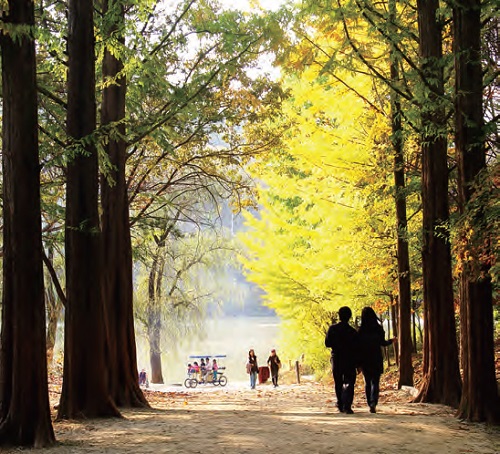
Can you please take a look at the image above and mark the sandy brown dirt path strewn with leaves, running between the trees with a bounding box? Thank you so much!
[6,384,500,454]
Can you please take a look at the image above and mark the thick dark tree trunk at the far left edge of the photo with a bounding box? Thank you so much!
[0,0,55,447]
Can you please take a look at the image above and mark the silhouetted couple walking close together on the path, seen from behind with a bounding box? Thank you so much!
[325,306,395,414]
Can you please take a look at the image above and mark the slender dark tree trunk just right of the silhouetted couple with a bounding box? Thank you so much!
[389,0,413,388]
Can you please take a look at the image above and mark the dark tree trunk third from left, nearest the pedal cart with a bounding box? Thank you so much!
[101,0,148,407]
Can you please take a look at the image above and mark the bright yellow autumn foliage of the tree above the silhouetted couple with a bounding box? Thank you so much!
[241,55,406,370]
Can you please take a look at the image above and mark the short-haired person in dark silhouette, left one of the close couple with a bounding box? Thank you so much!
[325,306,358,414]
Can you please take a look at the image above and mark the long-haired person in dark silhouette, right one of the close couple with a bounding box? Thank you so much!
[358,307,395,413]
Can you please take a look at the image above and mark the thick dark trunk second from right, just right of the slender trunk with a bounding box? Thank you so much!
[416,0,461,407]
